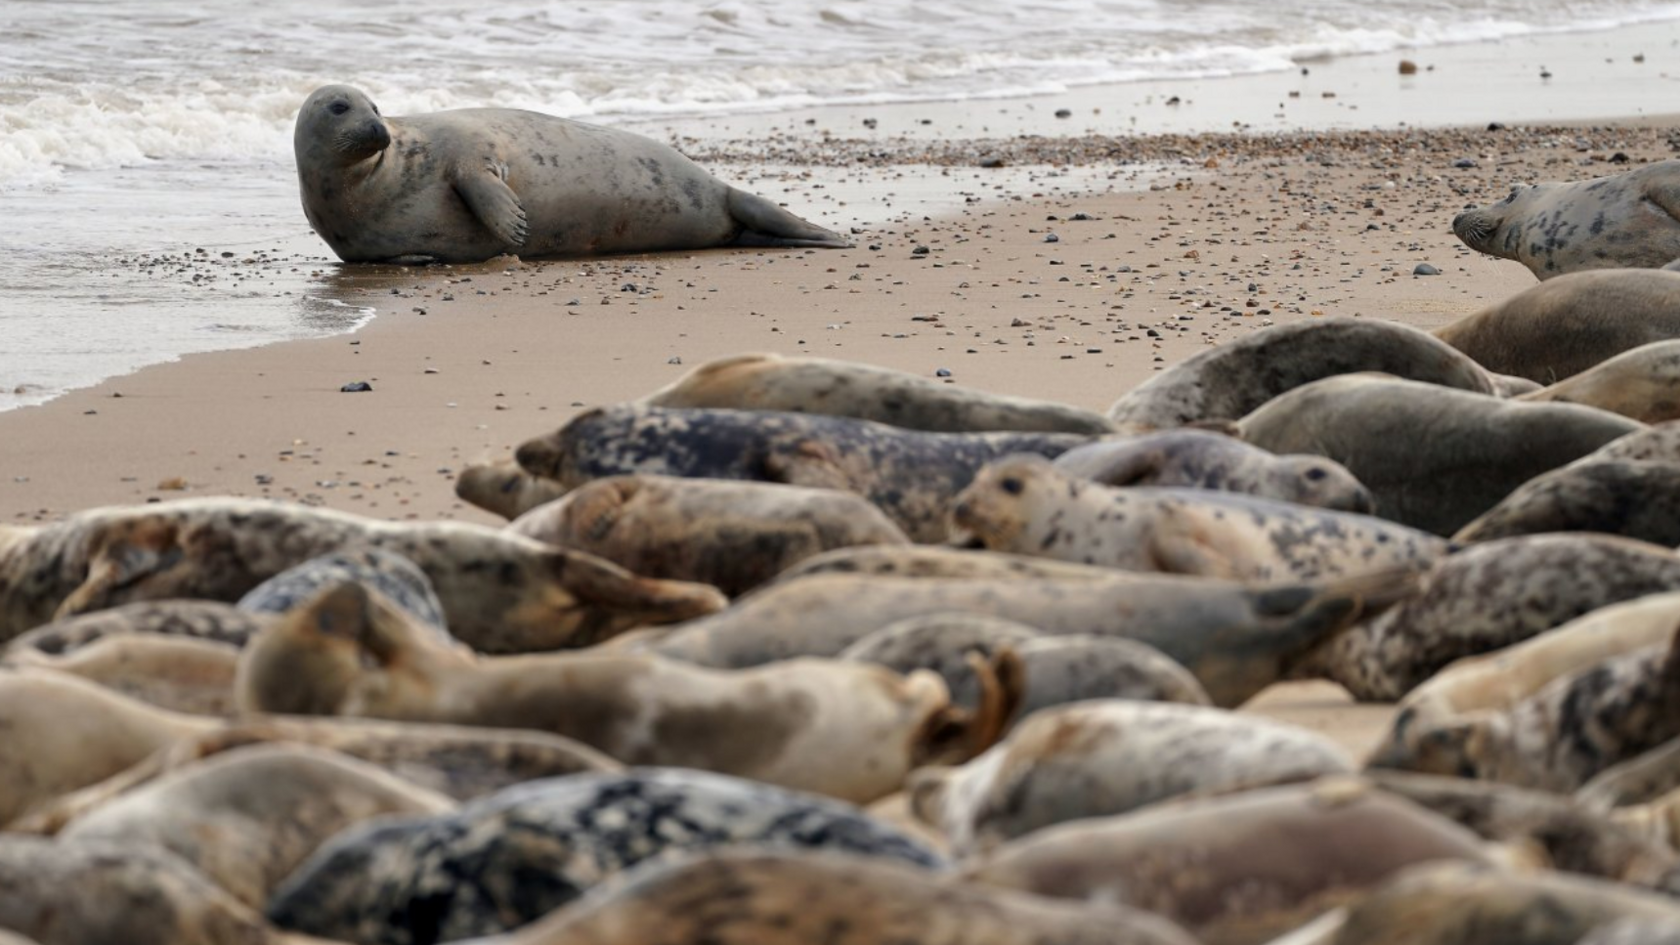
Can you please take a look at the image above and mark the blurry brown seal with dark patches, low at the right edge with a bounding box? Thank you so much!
[1362,768,1680,895]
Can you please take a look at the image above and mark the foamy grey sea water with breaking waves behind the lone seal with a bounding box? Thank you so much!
[0,0,1680,410]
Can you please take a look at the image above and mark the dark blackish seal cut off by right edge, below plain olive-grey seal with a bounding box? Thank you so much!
[1453,461,1680,546]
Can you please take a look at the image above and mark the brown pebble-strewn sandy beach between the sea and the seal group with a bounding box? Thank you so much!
[0,27,1680,747]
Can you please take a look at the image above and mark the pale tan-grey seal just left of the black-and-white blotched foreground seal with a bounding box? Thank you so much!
[59,743,455,910]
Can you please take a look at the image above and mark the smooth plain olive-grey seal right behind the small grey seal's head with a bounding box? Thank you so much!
[1236,375,1643,535]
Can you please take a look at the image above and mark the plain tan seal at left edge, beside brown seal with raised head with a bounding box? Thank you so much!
[0,634,239,716]
